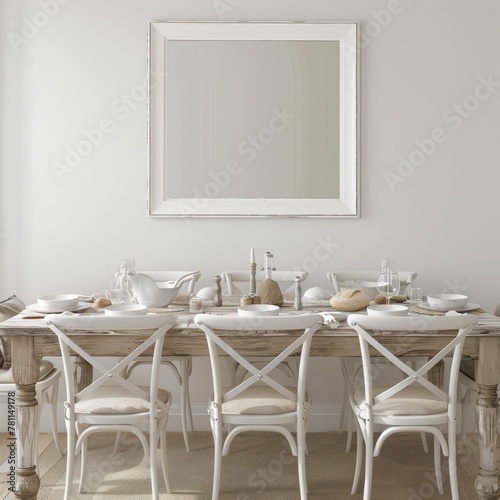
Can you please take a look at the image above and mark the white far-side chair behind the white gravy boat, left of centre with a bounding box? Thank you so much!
[130,271,201,451]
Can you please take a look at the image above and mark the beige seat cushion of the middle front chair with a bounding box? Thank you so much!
[222,386,311,415]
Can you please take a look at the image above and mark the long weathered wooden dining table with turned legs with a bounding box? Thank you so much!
[0,305,500,500]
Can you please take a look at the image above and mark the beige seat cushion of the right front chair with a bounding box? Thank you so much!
[354,385,448,416]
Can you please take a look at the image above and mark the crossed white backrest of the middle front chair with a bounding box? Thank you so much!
[194,314,323,405]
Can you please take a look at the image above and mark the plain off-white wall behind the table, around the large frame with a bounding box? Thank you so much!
[0,0,500,430]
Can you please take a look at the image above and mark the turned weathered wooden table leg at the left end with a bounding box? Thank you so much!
[11,337,40,500]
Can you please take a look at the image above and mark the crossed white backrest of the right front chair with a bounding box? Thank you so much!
[347,314,477,412]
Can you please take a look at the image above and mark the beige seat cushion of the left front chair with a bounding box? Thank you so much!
[75,385,171,415]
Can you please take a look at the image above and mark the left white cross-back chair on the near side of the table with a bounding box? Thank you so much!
[46,314,175,500]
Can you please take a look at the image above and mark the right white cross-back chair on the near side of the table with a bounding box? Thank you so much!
[347,314,477,500]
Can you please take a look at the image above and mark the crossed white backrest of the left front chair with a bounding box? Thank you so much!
[45,314,175,418]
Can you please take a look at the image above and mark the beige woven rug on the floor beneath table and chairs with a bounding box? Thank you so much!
[38,432,477,500]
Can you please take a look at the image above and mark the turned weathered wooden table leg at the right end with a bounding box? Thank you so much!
[474,337,500,500]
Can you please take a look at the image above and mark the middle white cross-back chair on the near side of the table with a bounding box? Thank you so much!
[195,314,323,500]
